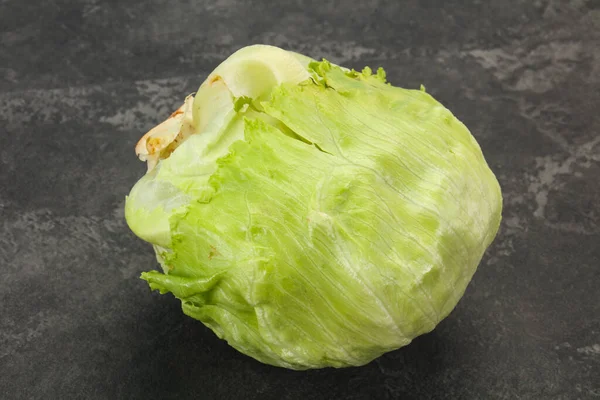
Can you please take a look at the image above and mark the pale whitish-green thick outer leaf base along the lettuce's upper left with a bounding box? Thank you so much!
[125,45,313,248]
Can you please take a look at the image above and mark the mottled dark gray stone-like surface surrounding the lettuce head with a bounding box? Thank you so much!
[0,0,600,400]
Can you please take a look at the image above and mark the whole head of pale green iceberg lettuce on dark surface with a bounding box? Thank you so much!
[125,45,502,369]
